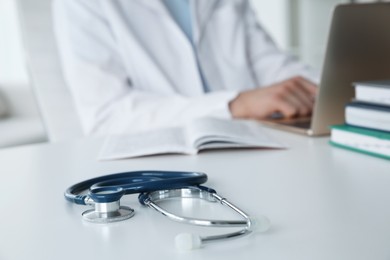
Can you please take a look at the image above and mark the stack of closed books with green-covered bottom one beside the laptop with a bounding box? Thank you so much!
[330,80,390,159]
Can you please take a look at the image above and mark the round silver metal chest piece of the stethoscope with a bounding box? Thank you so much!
[82,201,134,224]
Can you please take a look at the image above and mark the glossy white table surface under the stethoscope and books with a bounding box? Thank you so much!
[0,130,390,260]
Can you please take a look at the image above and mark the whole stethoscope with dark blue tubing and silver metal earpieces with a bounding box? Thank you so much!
[64,171,270,250]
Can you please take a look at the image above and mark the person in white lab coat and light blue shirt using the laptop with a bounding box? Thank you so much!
[54,0,316,135]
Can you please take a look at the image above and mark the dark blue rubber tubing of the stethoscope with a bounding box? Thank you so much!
[64,171,207,205]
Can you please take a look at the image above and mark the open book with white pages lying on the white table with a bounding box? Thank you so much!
[99,118,285,160]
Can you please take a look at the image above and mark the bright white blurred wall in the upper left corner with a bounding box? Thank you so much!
[0,0,29,86]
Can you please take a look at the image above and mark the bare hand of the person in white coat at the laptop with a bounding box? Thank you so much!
[229,77,317,119]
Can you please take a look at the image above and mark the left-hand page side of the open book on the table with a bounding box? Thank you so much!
[99,128,197,160]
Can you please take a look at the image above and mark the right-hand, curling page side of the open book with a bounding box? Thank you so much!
[186,118,285,150]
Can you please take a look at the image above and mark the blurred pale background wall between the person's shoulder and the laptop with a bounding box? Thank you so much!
[252,0,349,70]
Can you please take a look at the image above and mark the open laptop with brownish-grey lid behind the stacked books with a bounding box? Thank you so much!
[264,3,390,136]
